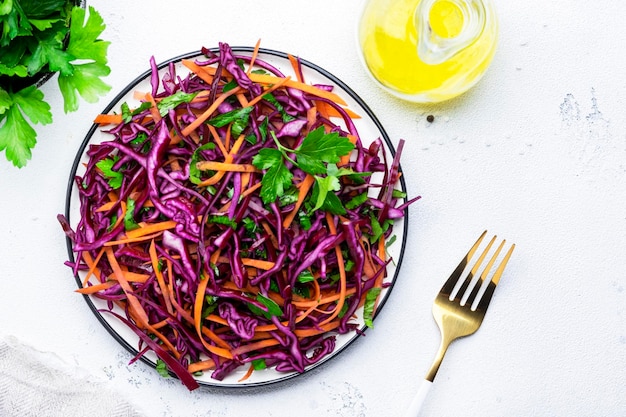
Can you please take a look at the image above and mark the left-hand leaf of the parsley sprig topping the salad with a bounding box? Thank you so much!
[252,148,293,204]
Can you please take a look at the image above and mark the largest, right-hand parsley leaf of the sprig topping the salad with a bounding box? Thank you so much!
[295,126,354,174]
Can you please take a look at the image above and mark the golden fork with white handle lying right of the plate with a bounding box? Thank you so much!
[405,230,515,417]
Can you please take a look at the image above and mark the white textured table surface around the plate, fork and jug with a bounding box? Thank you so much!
[0,0,626,417]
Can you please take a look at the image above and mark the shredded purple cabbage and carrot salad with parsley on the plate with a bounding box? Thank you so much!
[59,43,417,390]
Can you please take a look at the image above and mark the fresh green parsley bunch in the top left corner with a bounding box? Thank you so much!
[0,0,111,168]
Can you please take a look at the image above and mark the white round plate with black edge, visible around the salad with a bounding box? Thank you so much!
[65,47,408,387]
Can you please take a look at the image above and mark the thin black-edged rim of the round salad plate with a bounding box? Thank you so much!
[64,46,409,390]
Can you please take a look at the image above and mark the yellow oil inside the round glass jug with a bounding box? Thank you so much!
[358,0,497,102]
